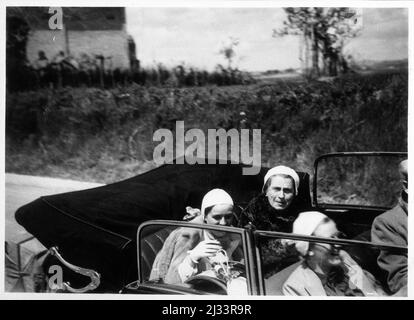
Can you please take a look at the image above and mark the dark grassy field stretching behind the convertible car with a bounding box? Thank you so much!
[6,71,408,183]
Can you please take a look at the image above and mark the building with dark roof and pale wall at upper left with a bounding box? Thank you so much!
[7,7,137,69]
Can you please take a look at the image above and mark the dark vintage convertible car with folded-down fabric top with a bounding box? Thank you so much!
[15,152,407,295]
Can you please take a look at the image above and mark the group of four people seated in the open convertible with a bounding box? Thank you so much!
[150,160,408,296]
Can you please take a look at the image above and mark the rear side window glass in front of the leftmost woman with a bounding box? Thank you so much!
[138,224,248,295]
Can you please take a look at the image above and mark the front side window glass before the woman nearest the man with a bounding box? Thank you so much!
[256,232,407,297]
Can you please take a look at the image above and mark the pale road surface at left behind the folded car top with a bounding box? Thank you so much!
[5,173,102,251]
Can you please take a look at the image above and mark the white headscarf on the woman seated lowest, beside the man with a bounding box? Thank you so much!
[293,211,328,256]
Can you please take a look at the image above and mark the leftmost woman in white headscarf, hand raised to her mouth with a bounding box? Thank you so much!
[150,189,241,284]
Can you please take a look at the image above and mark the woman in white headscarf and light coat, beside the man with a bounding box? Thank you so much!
[283,211,385,296]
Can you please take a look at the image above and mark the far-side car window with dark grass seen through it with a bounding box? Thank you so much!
[316,155,406,208]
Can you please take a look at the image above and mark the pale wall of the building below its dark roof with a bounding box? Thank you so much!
[26,26,130,69]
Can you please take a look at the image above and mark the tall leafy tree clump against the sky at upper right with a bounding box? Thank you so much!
[273,7,360,77]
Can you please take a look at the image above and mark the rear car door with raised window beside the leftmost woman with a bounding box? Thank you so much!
[123,220,258,295]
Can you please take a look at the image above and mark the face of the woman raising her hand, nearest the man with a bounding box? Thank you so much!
[308,220,342,270]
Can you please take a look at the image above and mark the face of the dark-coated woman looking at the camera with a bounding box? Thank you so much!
[266,175,295,210]
